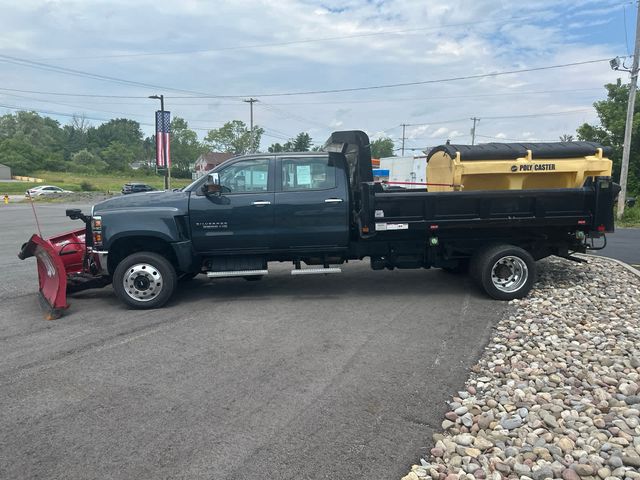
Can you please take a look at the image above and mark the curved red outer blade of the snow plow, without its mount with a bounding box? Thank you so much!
[18,234,68,320]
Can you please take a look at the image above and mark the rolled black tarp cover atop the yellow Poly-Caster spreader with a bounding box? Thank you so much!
[427,142,611,161]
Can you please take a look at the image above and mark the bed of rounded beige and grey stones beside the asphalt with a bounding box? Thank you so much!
[403,258,640,480]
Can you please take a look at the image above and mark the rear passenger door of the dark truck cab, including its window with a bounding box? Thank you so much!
[273,153,349,251]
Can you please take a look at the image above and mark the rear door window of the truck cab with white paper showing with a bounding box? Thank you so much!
[282,157,336,192]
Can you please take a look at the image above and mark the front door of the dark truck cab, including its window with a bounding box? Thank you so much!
[189,157,274,253]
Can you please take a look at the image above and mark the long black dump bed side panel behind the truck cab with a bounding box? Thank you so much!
[361,178,617,235]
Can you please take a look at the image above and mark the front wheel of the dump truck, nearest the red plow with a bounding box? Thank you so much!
[113,252,177,310]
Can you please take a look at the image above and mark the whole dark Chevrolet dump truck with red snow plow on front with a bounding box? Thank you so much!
[20,131,619,316]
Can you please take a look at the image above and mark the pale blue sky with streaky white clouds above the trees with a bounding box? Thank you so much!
[0,0,637,154]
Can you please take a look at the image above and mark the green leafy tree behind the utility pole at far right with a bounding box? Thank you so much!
[577,79,640,194]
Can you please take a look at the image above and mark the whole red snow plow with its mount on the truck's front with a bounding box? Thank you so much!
[18,211,109,320]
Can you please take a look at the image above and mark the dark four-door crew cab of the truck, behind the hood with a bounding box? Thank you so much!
[186,152,349,255]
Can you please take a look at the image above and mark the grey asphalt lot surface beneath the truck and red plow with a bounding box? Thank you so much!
[0,204,506,479]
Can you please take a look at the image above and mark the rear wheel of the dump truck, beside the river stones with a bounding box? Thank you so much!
[470,245,536,300]
